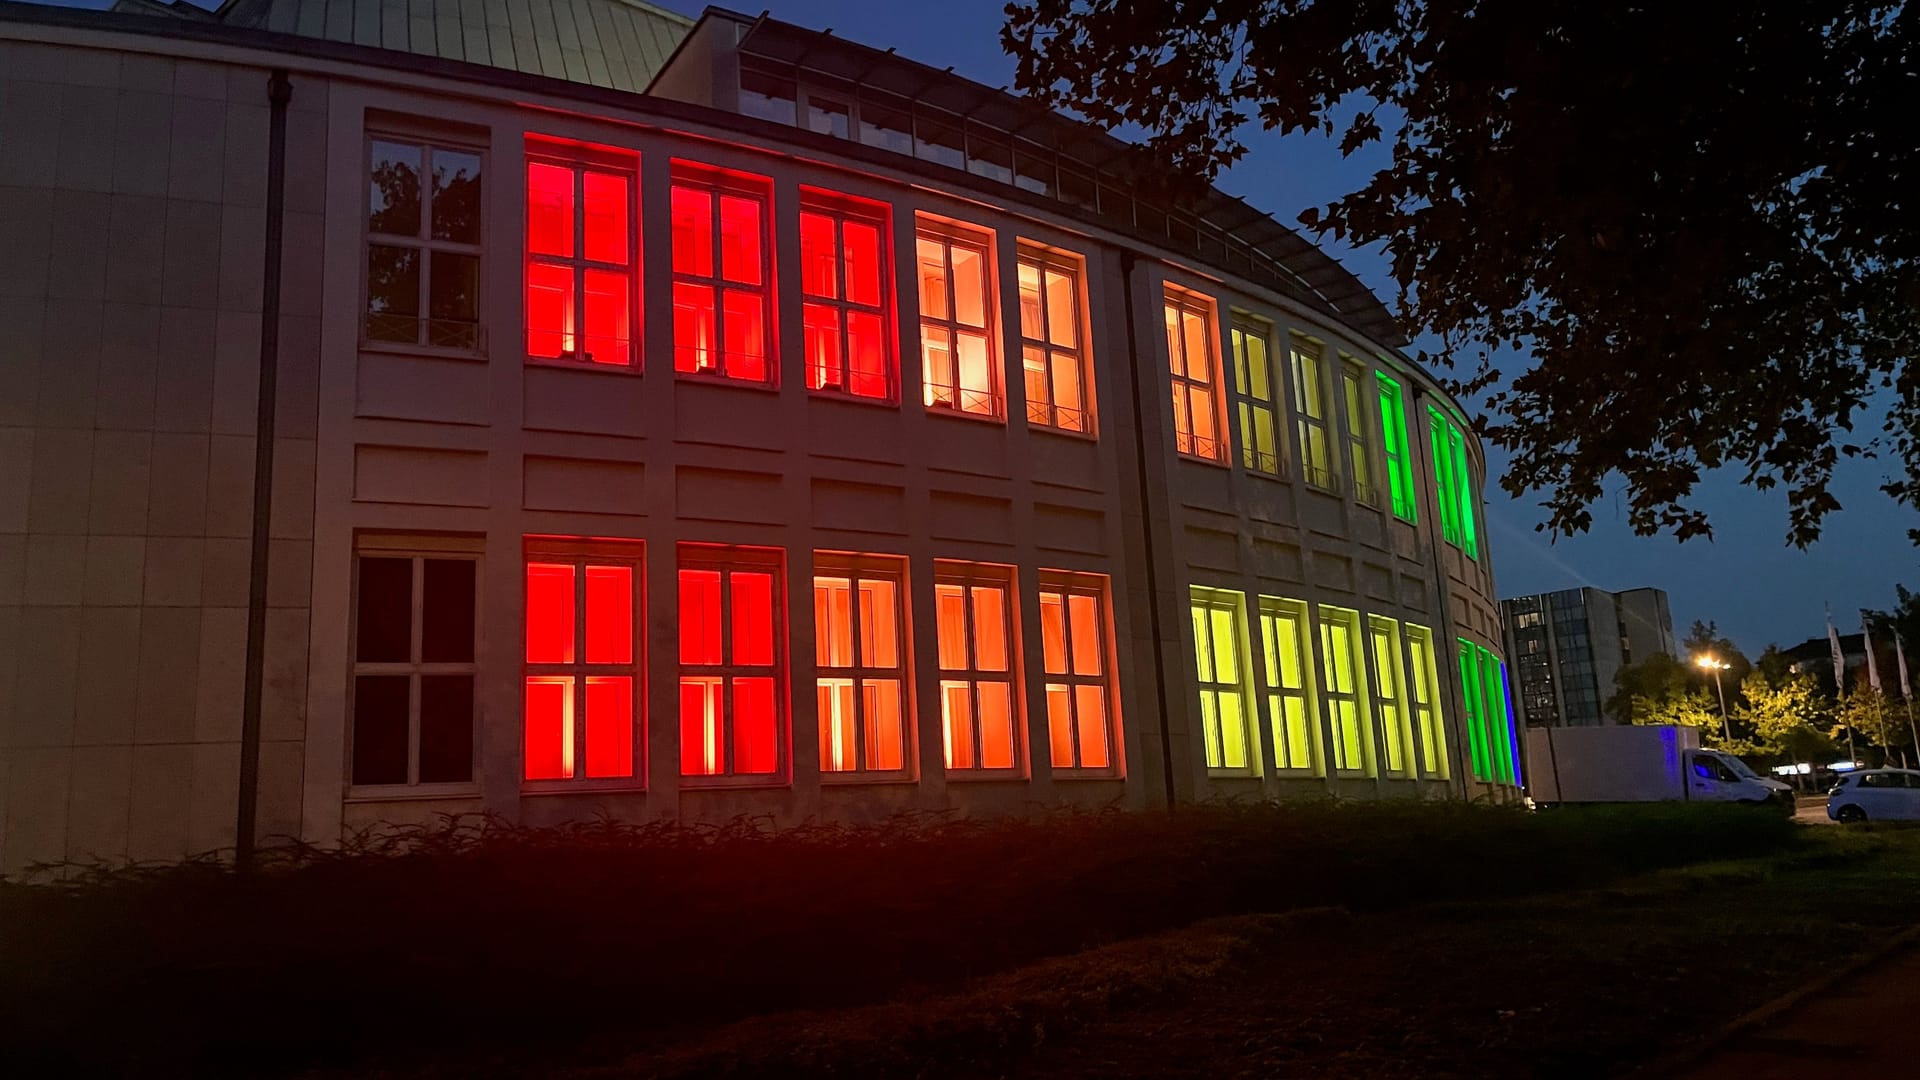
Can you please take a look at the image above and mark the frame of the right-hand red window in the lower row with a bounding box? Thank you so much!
[674,540,793,788]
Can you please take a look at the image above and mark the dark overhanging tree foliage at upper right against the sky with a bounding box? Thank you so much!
[1002,0,1920,544]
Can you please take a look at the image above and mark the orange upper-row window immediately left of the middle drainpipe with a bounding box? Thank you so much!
[1020,244,1092,432]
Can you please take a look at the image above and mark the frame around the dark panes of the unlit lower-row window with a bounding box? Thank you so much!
[342,536,486,801]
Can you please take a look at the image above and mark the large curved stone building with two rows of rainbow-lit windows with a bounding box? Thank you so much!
[0,0,1517,869]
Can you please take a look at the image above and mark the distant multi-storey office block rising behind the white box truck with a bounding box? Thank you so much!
[1500,588,1676,726]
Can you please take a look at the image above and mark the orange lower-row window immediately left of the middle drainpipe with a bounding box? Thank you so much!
[1041,571,1114,771]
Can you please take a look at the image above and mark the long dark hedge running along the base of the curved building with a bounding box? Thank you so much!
[0,801,1791,1074]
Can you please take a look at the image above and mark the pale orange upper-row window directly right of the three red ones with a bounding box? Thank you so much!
[914,219,1000,417]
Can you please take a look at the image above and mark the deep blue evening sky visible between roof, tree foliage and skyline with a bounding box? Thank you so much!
[48,0,1920,653]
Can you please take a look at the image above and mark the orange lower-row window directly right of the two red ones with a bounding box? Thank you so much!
[814,552,908,776]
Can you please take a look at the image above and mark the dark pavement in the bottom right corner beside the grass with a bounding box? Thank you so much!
[1663,942,1920,1080]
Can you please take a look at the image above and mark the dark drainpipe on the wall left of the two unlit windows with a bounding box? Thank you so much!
[234,69,294,871]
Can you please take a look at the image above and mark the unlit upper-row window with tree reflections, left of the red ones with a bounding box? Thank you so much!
[365,136,484,350]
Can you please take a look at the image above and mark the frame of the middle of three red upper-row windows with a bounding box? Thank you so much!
[666,158,780,390]
